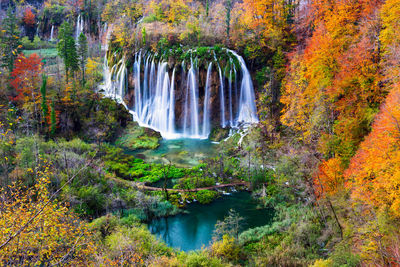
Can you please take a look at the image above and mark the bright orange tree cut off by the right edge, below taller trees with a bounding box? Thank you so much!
[345,84,400,218]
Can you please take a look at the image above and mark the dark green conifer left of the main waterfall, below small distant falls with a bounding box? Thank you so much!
[57,21,79,83]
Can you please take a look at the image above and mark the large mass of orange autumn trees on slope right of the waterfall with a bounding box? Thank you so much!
[281,0,385,201]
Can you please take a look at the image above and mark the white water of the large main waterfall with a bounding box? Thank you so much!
[100,50,258,139]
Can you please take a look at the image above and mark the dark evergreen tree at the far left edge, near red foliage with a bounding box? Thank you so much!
[0,7,21,73]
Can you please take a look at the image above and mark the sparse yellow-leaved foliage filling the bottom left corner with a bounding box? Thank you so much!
[0,166,95,266]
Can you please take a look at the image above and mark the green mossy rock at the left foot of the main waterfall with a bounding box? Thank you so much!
[115,122,161,150]
